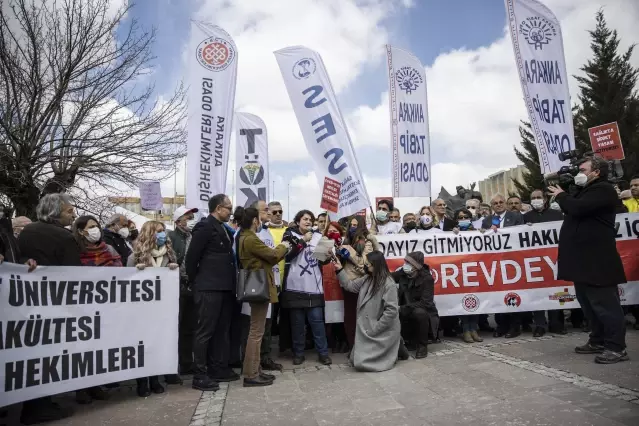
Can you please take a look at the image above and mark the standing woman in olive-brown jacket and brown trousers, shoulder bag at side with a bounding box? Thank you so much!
[233,207,290,387]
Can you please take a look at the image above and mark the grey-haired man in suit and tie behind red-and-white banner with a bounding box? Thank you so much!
[481,194,524,339]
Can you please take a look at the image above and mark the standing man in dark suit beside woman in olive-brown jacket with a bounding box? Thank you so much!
[185,194,240,391]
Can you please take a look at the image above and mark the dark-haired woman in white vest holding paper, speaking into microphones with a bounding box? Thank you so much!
[280,210,332,365]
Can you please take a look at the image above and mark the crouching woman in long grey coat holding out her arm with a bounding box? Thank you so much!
[334,251,401,371]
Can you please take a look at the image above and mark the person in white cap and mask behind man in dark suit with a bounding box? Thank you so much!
[166,206,198,376]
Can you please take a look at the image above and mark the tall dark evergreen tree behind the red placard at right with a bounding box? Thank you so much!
[574,11,639,180]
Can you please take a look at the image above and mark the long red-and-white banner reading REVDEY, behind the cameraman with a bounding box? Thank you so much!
[324,213,639,316]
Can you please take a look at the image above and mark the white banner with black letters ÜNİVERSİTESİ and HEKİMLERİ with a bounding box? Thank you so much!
[0,262,180,407]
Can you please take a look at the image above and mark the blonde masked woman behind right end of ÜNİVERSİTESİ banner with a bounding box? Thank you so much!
[126,220,178,398]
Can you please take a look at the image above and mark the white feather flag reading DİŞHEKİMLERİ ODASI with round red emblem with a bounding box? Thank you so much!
[186,21,237,214]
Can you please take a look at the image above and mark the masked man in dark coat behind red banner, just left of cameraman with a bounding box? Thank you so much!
[524,189,567,337]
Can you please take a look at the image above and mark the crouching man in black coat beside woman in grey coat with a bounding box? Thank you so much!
[392,251,439,359]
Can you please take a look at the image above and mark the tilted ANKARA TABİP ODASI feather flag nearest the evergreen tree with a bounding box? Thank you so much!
[505,0,575,174]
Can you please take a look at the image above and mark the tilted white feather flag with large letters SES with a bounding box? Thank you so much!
[275,46,370,217]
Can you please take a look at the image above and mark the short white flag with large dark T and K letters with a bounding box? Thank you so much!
[235,112,270,207]
